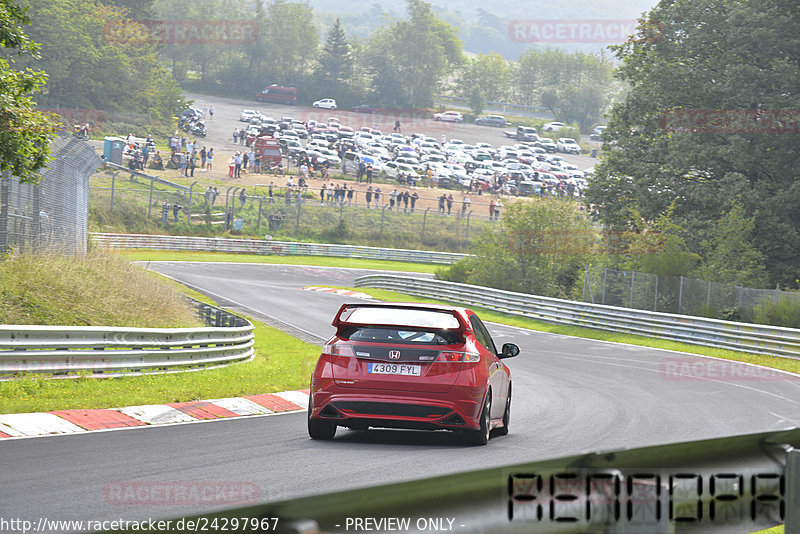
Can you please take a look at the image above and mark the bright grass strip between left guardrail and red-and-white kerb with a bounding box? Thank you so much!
[0,321,320,413]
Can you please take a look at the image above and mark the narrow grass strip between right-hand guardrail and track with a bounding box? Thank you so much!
[345,287,800,373]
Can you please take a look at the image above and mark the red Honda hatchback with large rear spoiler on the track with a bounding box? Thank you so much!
[308,303,519,445]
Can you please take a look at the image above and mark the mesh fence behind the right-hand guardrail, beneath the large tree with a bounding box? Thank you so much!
[582,267,800,320]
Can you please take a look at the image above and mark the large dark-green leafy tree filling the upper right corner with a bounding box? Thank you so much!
[587,0,800,285]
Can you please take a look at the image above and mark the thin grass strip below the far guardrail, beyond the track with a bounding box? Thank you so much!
[116,249,441,274]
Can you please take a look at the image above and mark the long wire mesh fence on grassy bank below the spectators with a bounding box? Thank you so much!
[91,182,499,251]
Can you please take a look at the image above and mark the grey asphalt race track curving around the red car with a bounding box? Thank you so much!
[0,263,800,520]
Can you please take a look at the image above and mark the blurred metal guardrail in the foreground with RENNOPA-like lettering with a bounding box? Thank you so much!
[139,428,800,534]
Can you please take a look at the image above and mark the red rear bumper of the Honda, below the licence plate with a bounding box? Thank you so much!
[310,381,485,430]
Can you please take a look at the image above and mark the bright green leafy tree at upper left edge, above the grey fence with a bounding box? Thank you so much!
[0,0,56,183]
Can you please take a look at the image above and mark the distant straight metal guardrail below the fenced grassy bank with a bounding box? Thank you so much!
[89,233,468,265]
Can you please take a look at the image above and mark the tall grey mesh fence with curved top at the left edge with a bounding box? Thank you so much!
[0,136,101,254]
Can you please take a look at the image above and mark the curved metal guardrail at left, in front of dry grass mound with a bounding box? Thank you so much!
[0,302,255,378]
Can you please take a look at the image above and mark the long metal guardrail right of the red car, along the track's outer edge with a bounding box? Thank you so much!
[355,275,800,358]
